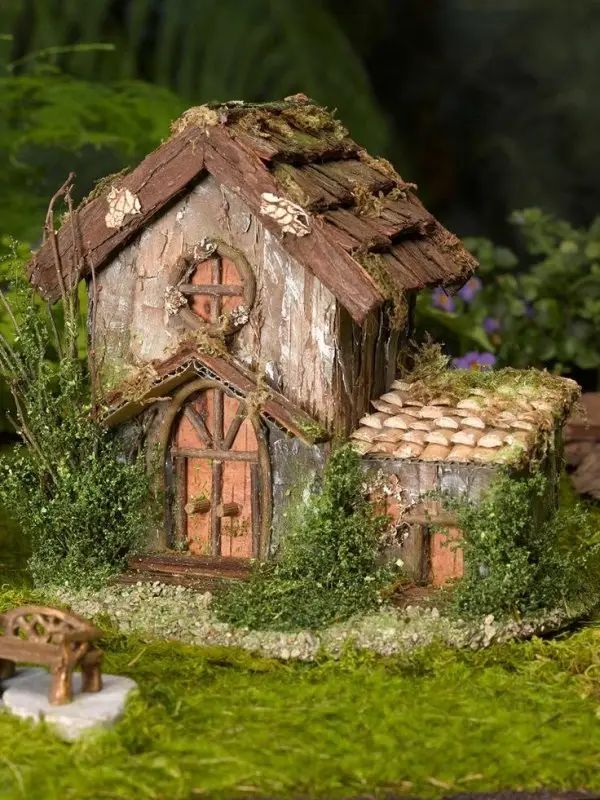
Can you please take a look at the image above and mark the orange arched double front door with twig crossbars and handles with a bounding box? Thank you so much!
[167,380,271,558]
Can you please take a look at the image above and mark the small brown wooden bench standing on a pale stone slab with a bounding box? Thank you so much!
[0,606,102,705]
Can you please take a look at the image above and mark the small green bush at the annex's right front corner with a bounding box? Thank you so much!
[448,474,600,616]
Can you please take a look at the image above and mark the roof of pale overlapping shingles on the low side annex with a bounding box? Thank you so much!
[351,378,577,464]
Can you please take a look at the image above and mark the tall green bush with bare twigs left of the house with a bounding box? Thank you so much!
[0,236,150,586]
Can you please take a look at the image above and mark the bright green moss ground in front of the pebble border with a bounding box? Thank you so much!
[0,590,600,800]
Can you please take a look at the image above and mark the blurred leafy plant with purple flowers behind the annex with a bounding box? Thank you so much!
[418,208,600,382]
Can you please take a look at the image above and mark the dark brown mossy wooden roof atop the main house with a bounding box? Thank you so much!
[28,95,476,324]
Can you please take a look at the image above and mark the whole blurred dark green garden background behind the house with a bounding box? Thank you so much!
[0,0,600,404]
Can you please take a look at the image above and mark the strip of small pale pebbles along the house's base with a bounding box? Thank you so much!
[53,582,590,662]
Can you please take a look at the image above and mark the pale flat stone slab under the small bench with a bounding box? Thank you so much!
[0,668,137,741]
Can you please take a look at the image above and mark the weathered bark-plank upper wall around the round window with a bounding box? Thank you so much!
[96,176,394,435]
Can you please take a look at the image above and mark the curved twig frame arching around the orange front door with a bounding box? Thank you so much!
[158,378,273,560]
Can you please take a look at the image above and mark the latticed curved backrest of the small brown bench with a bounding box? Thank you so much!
[0,606,101,645]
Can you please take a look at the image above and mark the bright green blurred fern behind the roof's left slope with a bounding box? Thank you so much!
[0,71,184,243]
